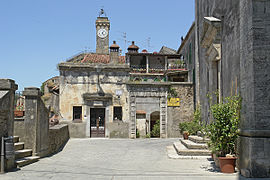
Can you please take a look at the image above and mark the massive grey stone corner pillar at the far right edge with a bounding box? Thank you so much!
[239,0,270,178]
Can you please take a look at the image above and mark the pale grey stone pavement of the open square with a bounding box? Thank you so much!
[0,139,266,180]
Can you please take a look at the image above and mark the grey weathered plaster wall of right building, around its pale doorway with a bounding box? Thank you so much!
[195,0,240,121]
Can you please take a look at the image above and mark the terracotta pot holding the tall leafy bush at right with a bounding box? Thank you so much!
[218,157,237,173]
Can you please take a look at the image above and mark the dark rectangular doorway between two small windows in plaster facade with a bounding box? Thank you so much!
[90,108,105,137]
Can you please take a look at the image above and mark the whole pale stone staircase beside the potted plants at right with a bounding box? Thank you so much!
[167,136,211,159]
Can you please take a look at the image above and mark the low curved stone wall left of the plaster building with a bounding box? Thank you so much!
[48,124,69,154]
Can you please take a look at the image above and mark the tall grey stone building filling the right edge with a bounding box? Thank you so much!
[194,0,270,177]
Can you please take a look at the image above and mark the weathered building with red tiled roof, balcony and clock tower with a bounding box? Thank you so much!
[58,11,194,138]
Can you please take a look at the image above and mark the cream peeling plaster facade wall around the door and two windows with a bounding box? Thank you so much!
[59,65,129,137]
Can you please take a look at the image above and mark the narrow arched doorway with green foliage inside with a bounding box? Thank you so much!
[150,111,160,137]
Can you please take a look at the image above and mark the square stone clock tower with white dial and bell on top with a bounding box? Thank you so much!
[96,9,110,54]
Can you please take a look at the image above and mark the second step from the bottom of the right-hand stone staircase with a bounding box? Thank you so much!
[173,142,211,156]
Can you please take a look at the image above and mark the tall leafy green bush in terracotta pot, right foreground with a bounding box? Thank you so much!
[208,96,241,173]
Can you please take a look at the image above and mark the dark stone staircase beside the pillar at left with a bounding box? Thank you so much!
[13,136,39,167]
